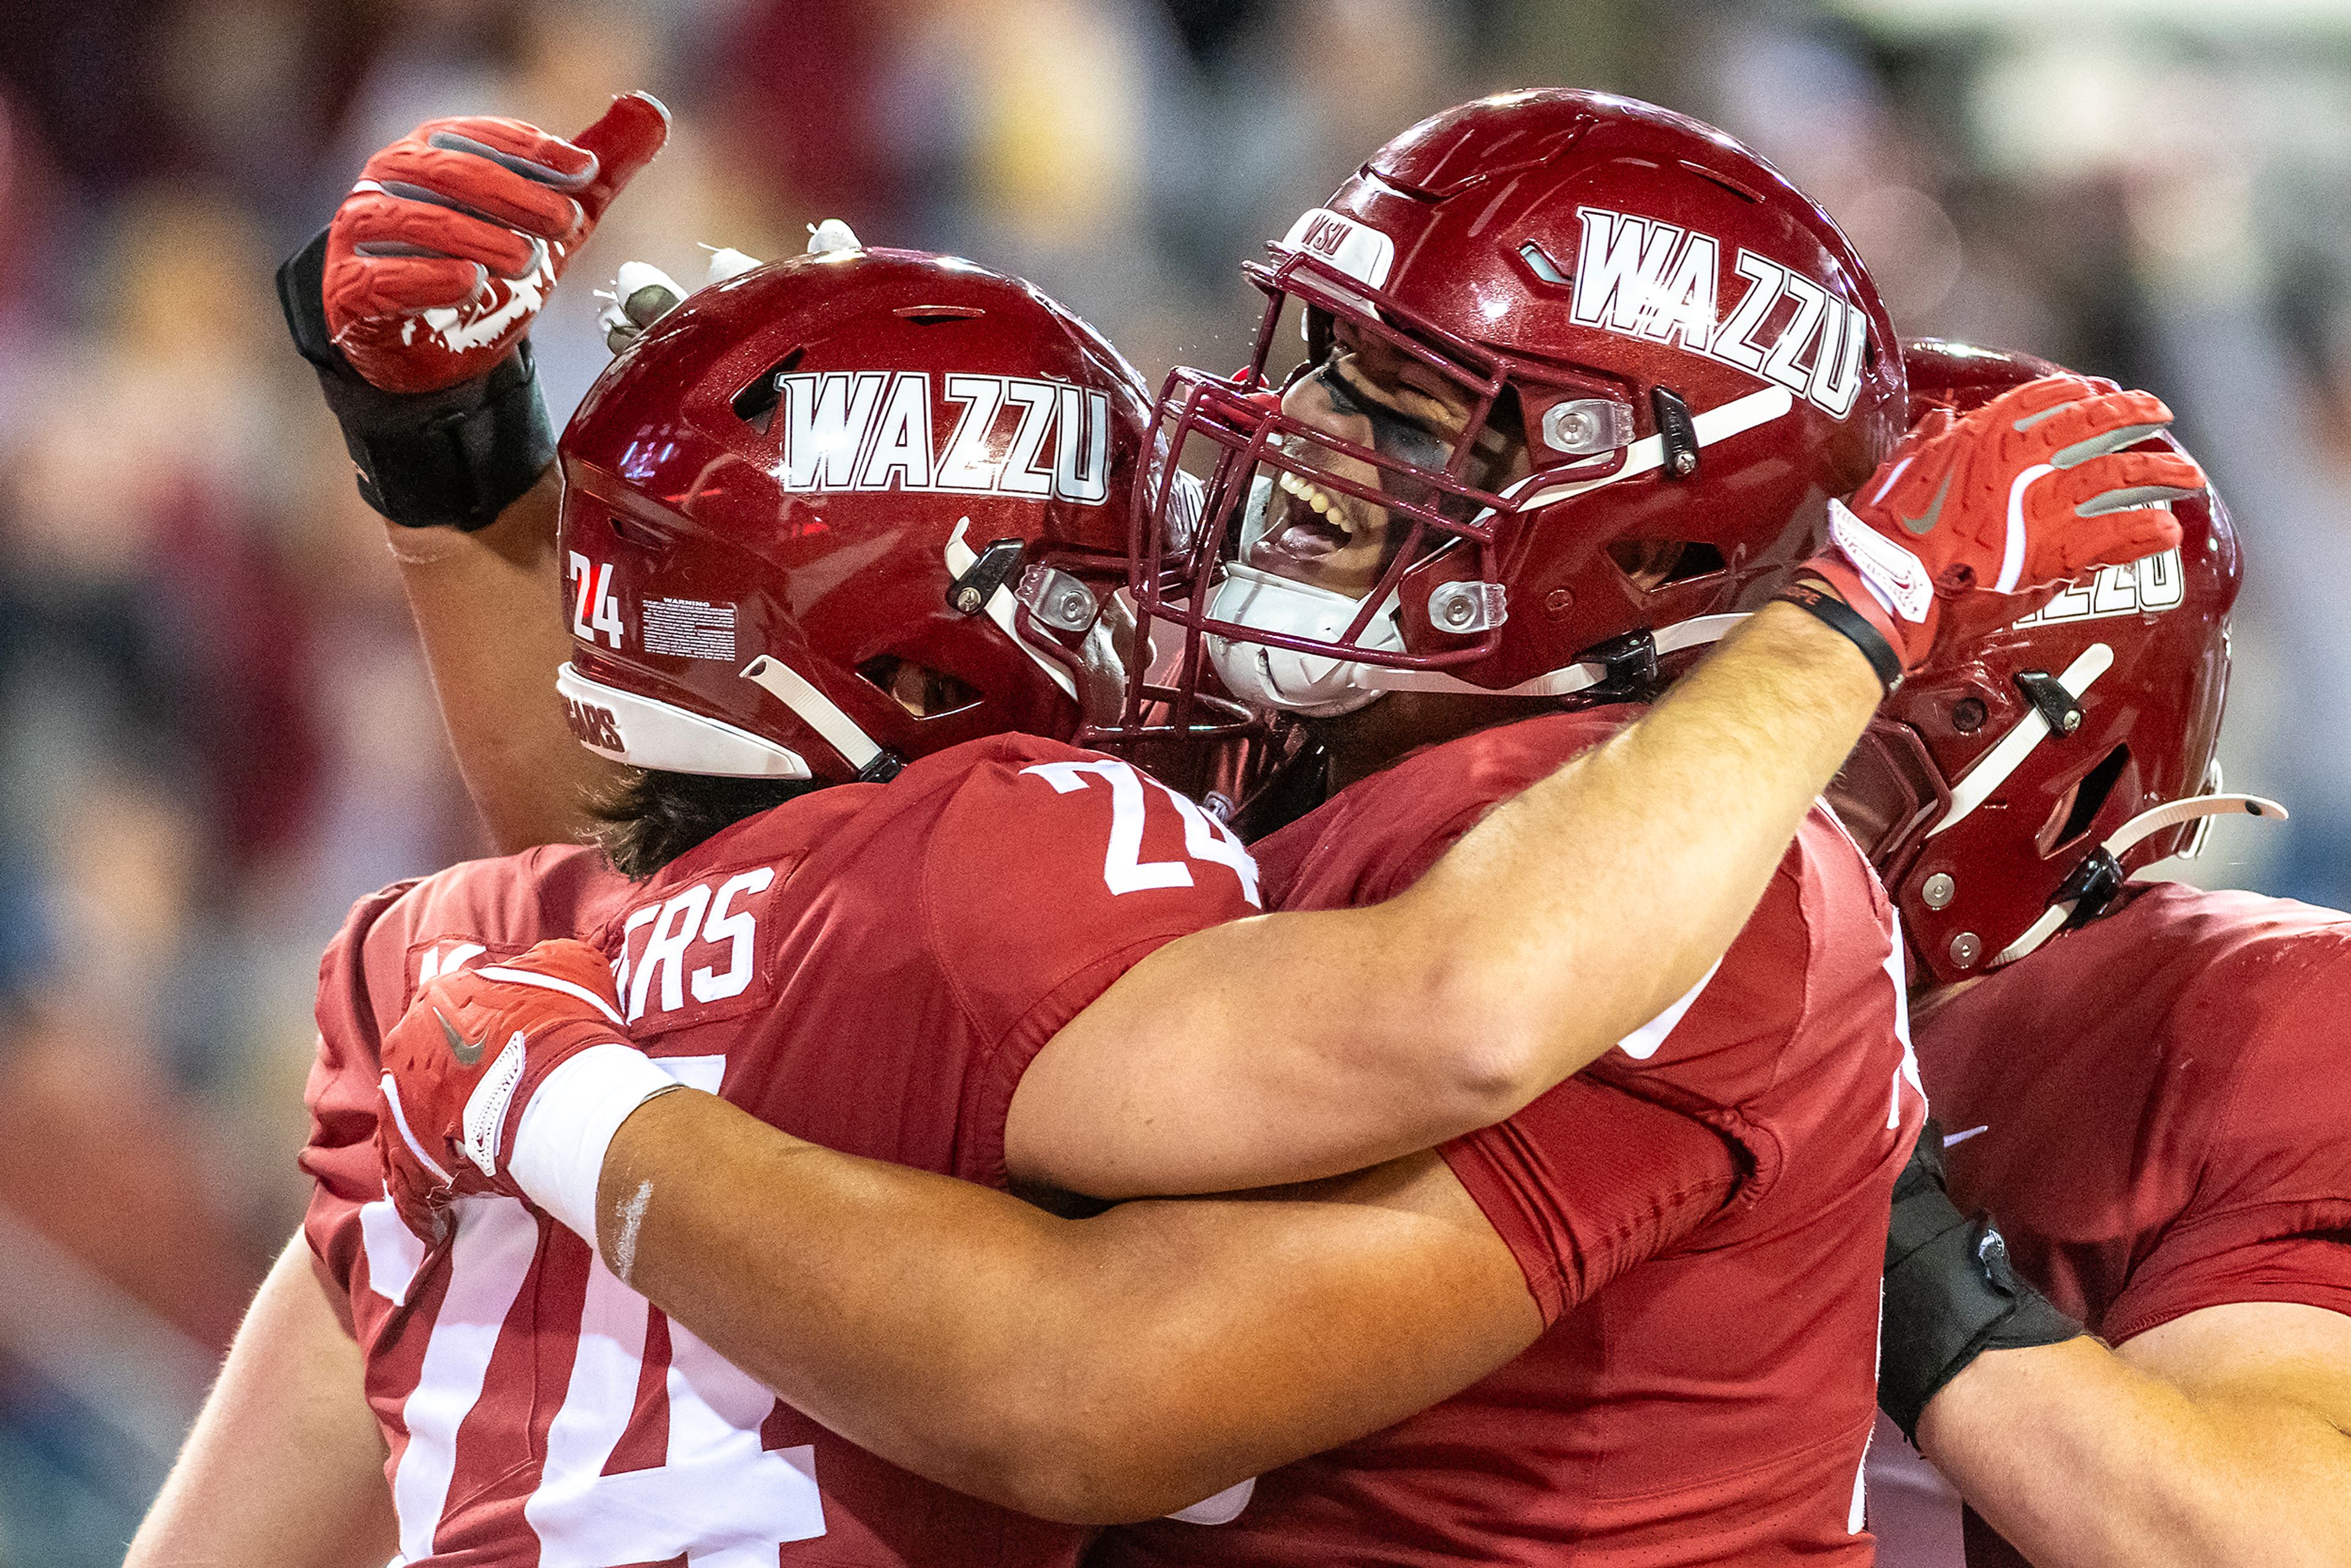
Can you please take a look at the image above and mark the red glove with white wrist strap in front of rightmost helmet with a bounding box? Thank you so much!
[1803,376,2205,670]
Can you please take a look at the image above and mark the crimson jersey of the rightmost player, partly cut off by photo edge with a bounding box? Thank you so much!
[1872,882,2351,1568]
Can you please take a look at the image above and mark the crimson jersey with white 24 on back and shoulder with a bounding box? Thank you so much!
[303,736,1258,1568]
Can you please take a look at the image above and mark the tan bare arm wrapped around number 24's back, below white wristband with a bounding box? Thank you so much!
[597,1093,1540,1523]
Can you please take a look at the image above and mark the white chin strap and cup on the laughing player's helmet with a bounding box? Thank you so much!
[1209,564,1747,719]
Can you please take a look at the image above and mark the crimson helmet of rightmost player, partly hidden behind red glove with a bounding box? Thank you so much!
[1829,341,2285,983]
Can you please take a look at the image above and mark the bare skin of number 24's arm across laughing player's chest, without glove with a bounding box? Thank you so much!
[1007,604,1883,1196]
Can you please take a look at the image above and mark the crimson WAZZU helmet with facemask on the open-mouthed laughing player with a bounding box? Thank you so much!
[1133,92,1904,715]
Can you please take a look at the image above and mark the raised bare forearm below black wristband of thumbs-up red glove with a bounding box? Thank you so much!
[386,468,611,853]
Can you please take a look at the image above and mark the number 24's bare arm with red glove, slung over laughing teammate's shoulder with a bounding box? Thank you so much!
[1007,376,2203,1196]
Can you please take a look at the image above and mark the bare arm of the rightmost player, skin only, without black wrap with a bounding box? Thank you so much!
[1918,1302,2351,1568]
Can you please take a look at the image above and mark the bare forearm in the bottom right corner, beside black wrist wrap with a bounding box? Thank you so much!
[1918,1338,2351,1568]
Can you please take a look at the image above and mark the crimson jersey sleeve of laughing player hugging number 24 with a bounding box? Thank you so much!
[1439,1077,1744,1326]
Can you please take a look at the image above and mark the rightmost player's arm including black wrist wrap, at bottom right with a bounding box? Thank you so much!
[1878,1105,2351,1568]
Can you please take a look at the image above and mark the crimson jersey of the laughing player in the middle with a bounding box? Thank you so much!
[1093,708,1923,1568]
